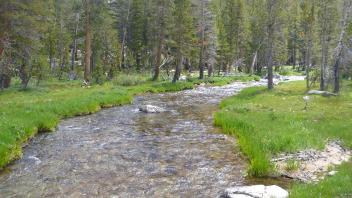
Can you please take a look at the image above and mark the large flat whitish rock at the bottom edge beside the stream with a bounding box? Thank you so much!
[219,185,288,198]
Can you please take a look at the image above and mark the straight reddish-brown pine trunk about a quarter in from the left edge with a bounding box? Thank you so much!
[84,0,92,83]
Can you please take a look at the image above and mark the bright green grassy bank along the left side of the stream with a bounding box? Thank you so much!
[0,75,259,169]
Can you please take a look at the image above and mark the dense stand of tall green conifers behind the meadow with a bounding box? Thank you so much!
[0,0,352,92]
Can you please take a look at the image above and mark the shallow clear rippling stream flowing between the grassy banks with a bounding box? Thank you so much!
[0,81,302,197]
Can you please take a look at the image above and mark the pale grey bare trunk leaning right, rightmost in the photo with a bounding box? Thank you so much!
[333,0,352,93]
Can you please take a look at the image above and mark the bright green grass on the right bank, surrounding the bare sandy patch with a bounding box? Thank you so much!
[215,81,352,197]
